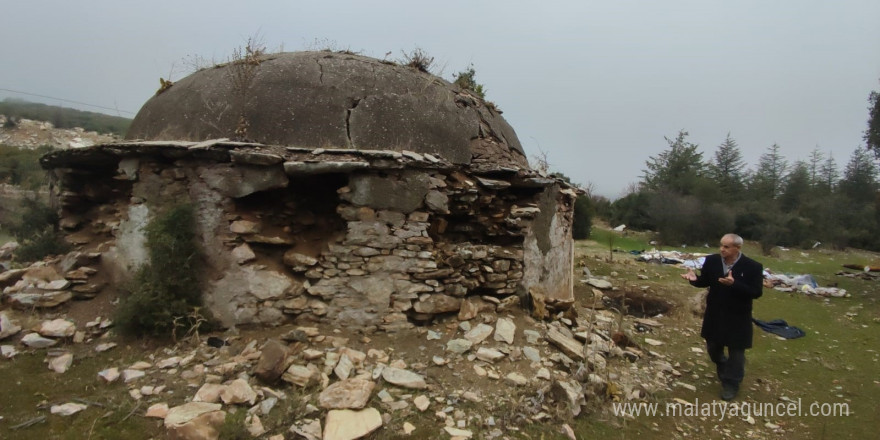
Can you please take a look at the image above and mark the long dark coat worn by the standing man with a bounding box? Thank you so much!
[691,254,764,348]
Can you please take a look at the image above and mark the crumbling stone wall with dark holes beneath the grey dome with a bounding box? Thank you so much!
[44,143,576,331]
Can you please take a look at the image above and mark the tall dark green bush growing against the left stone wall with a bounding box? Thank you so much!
[116,205,204,336]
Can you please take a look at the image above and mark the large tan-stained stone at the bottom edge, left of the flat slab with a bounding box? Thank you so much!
[165,402,226,440]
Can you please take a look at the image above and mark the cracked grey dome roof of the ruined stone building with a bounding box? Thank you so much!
[126,52,528,168]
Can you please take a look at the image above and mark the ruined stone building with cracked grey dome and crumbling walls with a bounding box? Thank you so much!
[42,52,577,330]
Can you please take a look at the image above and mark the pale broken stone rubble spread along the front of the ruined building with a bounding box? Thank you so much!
[0,300,681,439]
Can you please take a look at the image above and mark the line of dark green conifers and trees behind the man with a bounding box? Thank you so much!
[574,83,880,252]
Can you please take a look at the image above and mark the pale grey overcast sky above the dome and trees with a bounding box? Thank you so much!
[0,0,880,198]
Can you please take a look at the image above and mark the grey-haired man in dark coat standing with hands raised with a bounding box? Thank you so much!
[681,234,764,400]
